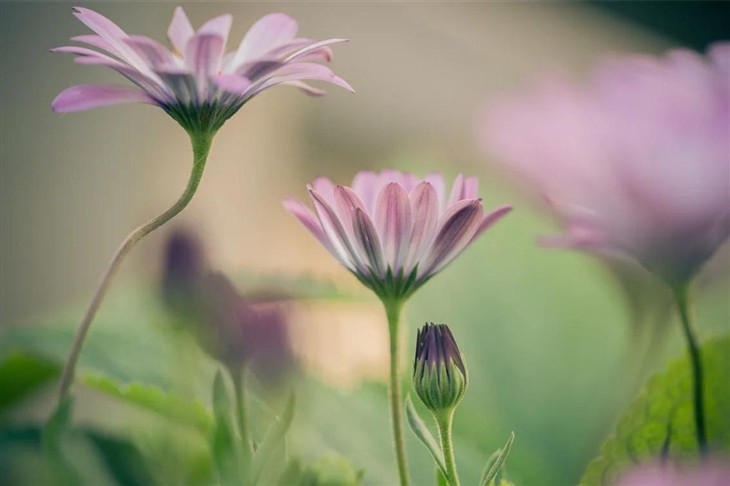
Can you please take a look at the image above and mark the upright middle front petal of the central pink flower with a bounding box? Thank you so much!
[374,182,413,274]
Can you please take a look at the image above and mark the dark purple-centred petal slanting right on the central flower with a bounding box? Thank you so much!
[418,199,484,278]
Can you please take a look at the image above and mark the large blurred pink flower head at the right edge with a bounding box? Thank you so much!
[479,43,730,285]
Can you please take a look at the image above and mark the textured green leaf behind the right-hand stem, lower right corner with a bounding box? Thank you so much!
[581,336,730,486]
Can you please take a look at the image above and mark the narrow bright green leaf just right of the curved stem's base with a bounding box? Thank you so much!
[81,373,213,434]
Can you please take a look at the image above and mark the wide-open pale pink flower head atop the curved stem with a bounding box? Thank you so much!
[52,7,352,129]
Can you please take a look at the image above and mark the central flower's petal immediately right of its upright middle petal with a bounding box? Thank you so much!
[406,181,439,269]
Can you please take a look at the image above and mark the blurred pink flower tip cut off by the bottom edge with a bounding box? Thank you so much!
[616,461,730,486]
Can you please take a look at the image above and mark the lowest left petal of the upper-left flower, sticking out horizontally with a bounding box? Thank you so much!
[51,84,156,113]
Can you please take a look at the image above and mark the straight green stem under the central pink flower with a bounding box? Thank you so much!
[383,298,410,486]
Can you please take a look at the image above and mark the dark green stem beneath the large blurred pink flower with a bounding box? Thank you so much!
[674,284,707,455]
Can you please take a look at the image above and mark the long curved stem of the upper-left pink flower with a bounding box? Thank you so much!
[58,132,215,403]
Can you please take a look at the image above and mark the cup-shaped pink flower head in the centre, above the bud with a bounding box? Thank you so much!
[284,170,511,297]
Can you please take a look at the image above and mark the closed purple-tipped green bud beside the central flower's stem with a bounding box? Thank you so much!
[413,323,467,414]
